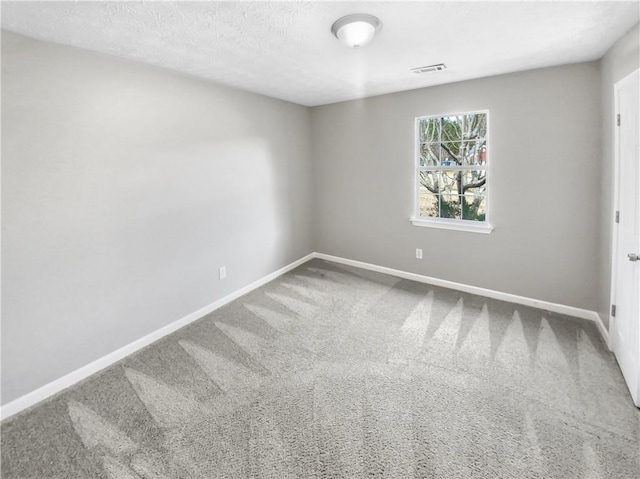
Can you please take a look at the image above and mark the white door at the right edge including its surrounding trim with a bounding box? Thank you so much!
[610,70,640,407]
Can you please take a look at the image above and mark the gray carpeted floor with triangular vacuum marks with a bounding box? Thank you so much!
[2,259,640,479]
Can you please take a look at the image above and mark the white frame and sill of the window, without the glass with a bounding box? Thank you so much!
[411,110,493,234]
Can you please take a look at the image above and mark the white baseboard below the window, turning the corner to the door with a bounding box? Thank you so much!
[313,253,610,348]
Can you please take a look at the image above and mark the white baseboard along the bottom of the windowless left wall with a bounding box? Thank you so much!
[1,253,314,419]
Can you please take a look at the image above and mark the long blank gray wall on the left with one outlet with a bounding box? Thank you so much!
[2,32,312,403]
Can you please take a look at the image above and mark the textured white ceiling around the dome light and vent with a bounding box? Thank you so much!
[2,1,640,106]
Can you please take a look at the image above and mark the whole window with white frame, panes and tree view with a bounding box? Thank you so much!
[411,111,491,233]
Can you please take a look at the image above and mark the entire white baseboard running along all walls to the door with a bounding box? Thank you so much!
[0,253,609,419]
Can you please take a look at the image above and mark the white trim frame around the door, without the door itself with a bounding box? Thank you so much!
[609,68,640,398]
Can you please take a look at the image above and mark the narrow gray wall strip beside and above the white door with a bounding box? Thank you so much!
[598,24,640,326]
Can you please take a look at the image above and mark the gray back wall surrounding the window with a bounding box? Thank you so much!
[311,62,601,311]
